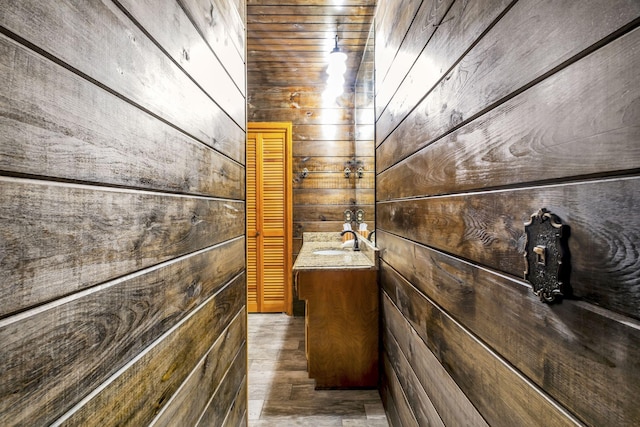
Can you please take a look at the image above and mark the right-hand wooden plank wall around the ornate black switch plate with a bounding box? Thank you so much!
[375,0,640,426]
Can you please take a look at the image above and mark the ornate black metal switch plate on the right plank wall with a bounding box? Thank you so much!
[524,208,569,303]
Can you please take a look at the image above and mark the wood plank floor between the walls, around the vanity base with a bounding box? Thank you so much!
[248,314,389,427]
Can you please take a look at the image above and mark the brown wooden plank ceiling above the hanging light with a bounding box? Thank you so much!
[247,0,375,87]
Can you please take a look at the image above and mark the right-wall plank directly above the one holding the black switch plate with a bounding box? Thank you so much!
[378,30,640,200]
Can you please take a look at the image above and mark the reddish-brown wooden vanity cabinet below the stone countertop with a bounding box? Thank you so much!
[297,269,379,389]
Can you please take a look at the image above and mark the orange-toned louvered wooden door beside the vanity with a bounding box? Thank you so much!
[247,123,292,313]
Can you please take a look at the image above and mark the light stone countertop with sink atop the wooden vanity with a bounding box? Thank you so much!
[293,233,378,272]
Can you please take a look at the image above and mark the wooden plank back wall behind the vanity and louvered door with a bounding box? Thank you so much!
[247,87,358,315]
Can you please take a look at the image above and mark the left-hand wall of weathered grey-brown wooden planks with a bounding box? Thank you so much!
[0,0,247,426]
